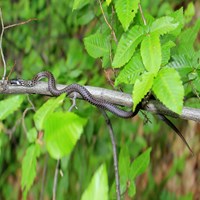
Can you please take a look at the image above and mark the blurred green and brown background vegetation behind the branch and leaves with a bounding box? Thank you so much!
[0,0,200,200]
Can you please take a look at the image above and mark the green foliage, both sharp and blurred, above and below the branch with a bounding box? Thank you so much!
[0,0,200,200]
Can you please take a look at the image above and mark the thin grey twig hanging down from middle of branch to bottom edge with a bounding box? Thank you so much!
[100,109,121,200]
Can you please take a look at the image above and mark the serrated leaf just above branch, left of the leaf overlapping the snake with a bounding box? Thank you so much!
[115,54,145,85]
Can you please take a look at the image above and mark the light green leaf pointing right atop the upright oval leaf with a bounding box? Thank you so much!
[150,16,179,35]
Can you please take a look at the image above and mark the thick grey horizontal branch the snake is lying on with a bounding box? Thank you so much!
[0,81,200,122]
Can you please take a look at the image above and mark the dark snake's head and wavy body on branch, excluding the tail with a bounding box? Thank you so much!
[10,71,140,118]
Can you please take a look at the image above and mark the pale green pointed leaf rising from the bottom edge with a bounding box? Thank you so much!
[81,164,108,200]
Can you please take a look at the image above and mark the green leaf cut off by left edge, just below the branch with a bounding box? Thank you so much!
[0,95,24,120]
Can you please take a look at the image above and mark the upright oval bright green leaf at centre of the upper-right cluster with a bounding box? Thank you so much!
[141,34,162,75]
